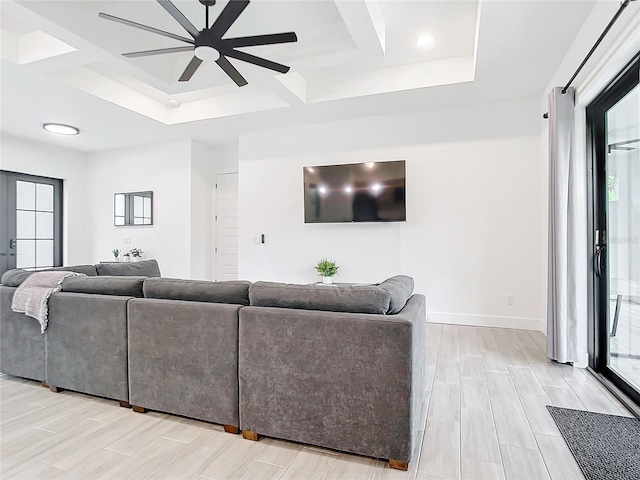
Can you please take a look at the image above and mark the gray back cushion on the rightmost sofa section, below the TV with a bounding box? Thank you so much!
[249,282,391,315]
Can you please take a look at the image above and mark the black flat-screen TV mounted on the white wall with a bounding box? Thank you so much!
[304,160,407,223]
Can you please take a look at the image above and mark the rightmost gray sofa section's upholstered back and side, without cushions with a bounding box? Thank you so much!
[239,295,426,462]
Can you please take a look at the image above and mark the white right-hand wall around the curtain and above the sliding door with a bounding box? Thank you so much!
[540,0,640,367]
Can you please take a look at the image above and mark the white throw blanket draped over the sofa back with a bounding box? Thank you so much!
[11,271,86,333]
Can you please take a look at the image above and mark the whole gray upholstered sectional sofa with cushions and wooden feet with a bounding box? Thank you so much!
[0,261,426,469]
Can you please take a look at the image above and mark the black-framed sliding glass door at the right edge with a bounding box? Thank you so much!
[587,54,640,403]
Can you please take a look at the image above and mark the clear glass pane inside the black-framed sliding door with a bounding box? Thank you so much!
[605,85,640,390]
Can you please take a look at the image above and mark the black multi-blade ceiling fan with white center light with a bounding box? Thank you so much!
[98,0,298,87]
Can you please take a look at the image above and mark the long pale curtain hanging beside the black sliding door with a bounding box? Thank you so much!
[547,87,586,363]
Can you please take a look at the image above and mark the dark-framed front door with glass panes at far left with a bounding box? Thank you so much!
[0,171,62,274]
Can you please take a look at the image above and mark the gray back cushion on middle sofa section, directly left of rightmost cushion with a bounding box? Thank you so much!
[144,278,251,305]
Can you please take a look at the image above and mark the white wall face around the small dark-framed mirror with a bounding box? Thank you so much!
[86,141,192,278]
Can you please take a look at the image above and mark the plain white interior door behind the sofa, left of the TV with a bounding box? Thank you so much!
[215,173,238,280]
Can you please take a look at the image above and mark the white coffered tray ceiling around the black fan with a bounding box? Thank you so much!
[0,0,594,151]
